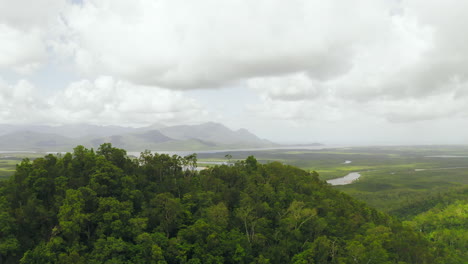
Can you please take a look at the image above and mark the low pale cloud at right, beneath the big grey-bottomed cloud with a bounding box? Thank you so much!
[248,74,468,124]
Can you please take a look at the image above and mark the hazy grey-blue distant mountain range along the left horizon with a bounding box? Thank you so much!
[0,122,279,151]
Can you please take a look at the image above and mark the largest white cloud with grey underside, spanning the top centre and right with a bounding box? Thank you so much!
[58,0,468,125]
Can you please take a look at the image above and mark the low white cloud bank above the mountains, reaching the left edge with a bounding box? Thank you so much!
[0,76,206,126]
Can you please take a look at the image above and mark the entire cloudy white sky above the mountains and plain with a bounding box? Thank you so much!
[0,0,468,145]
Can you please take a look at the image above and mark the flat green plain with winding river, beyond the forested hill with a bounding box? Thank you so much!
[198,146,468,217]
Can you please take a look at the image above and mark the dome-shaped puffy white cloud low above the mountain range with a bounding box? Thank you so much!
[50,77,205,125]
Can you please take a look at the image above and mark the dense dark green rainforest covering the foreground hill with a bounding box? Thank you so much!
[0,144,460,264]
